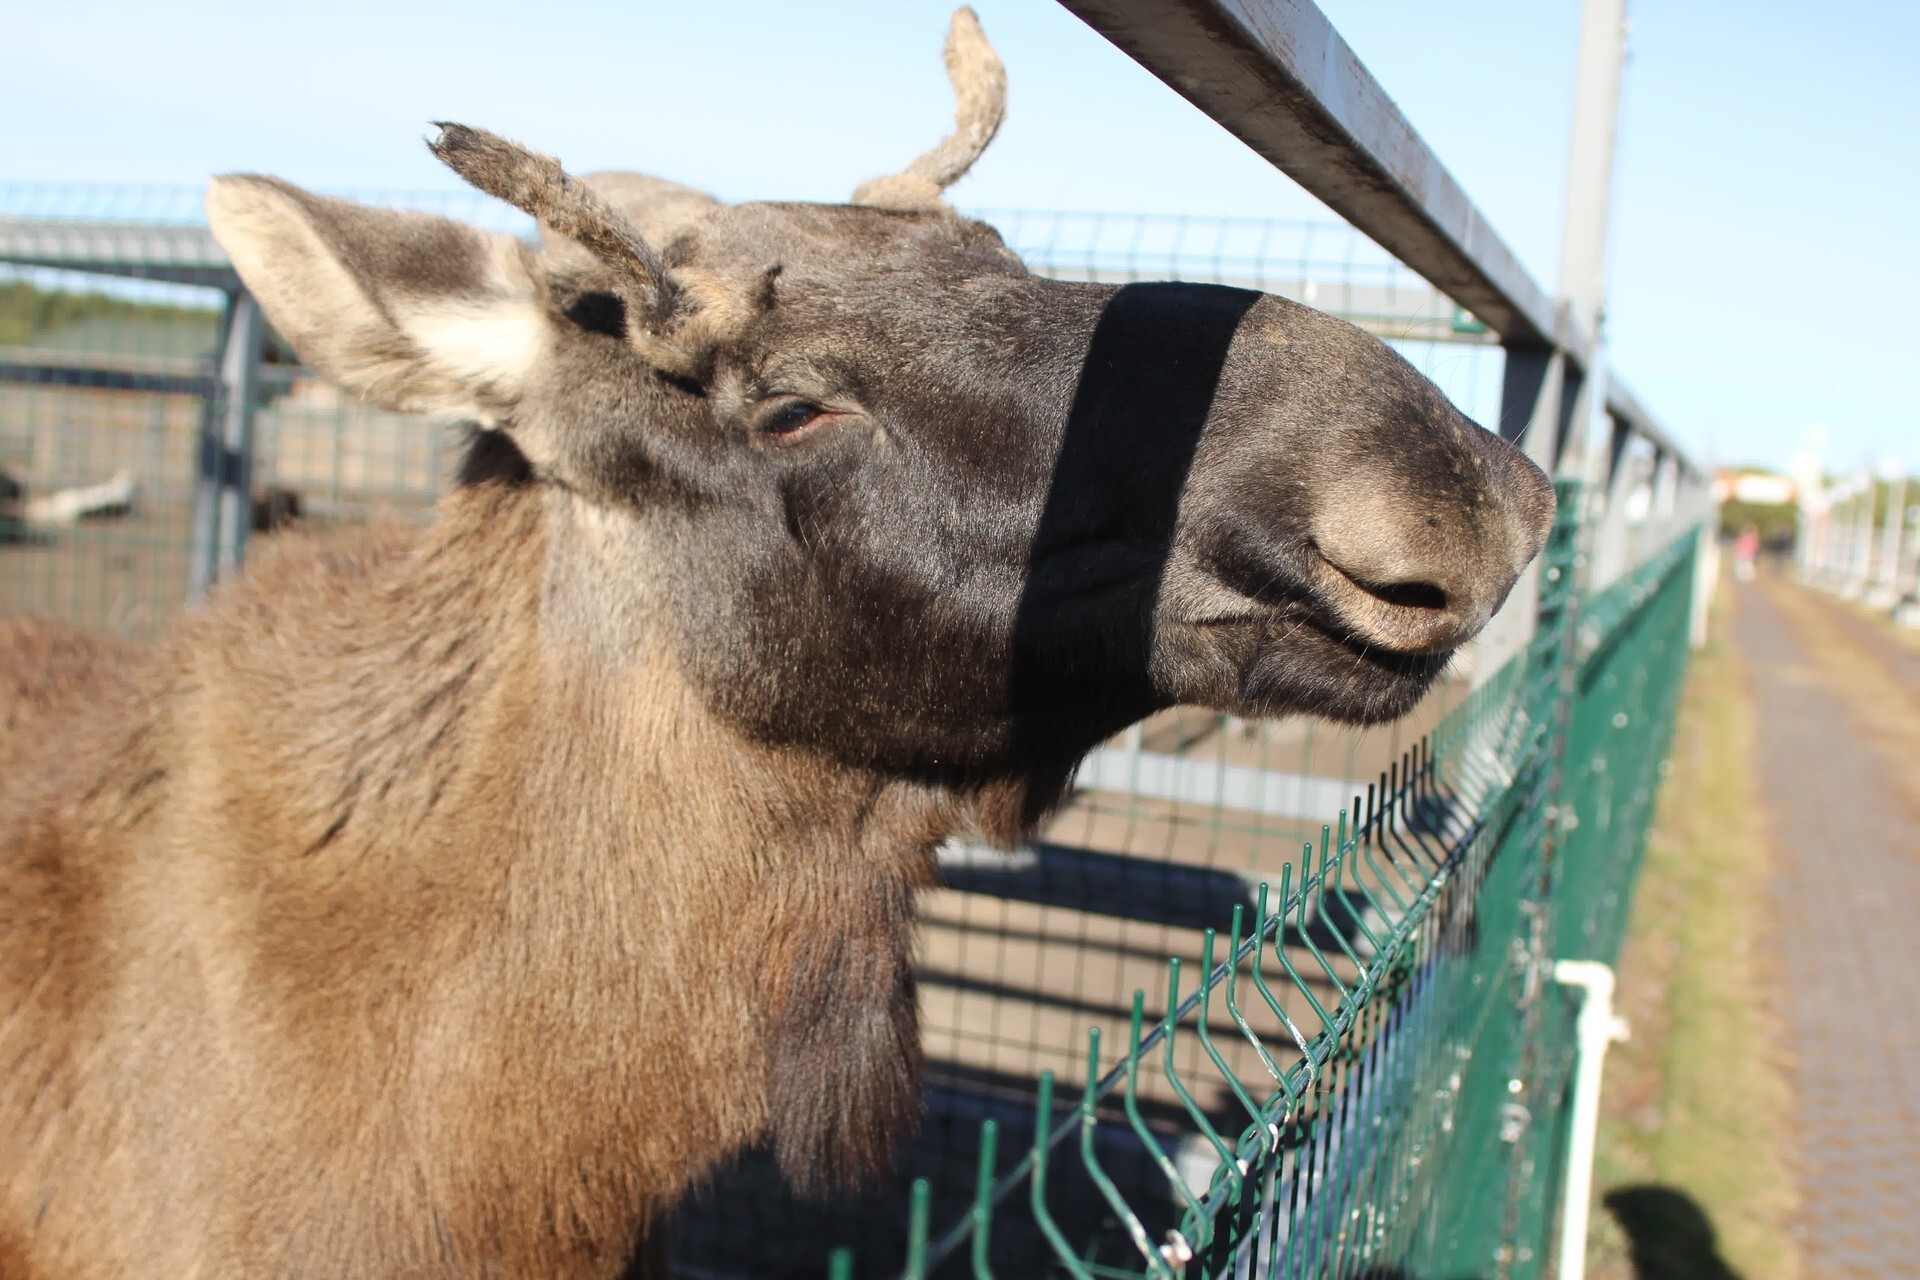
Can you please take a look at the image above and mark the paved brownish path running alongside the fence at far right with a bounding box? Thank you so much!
[1734,580,1920,1278]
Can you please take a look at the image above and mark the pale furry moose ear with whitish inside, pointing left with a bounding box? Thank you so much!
[207,175,549,422]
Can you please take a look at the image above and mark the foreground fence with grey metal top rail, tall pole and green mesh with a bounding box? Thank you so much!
[810,0,1712,1276]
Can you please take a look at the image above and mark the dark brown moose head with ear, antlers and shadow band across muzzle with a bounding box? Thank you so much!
[207,10,1553,832]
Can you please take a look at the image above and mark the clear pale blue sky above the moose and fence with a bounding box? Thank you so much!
[0,0,1920,468]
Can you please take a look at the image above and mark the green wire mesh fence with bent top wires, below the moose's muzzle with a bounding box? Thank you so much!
[871,486,1695,1280]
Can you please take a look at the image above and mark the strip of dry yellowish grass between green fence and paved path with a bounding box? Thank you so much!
[1590,591,1801,1280]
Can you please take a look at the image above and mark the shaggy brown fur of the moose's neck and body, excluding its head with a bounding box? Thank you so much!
[0,475,952,1280]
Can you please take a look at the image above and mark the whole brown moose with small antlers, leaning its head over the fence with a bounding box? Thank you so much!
[0,10,1553,1280]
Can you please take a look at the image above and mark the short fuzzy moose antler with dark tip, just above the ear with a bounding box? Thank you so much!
[426,121,672,317]
